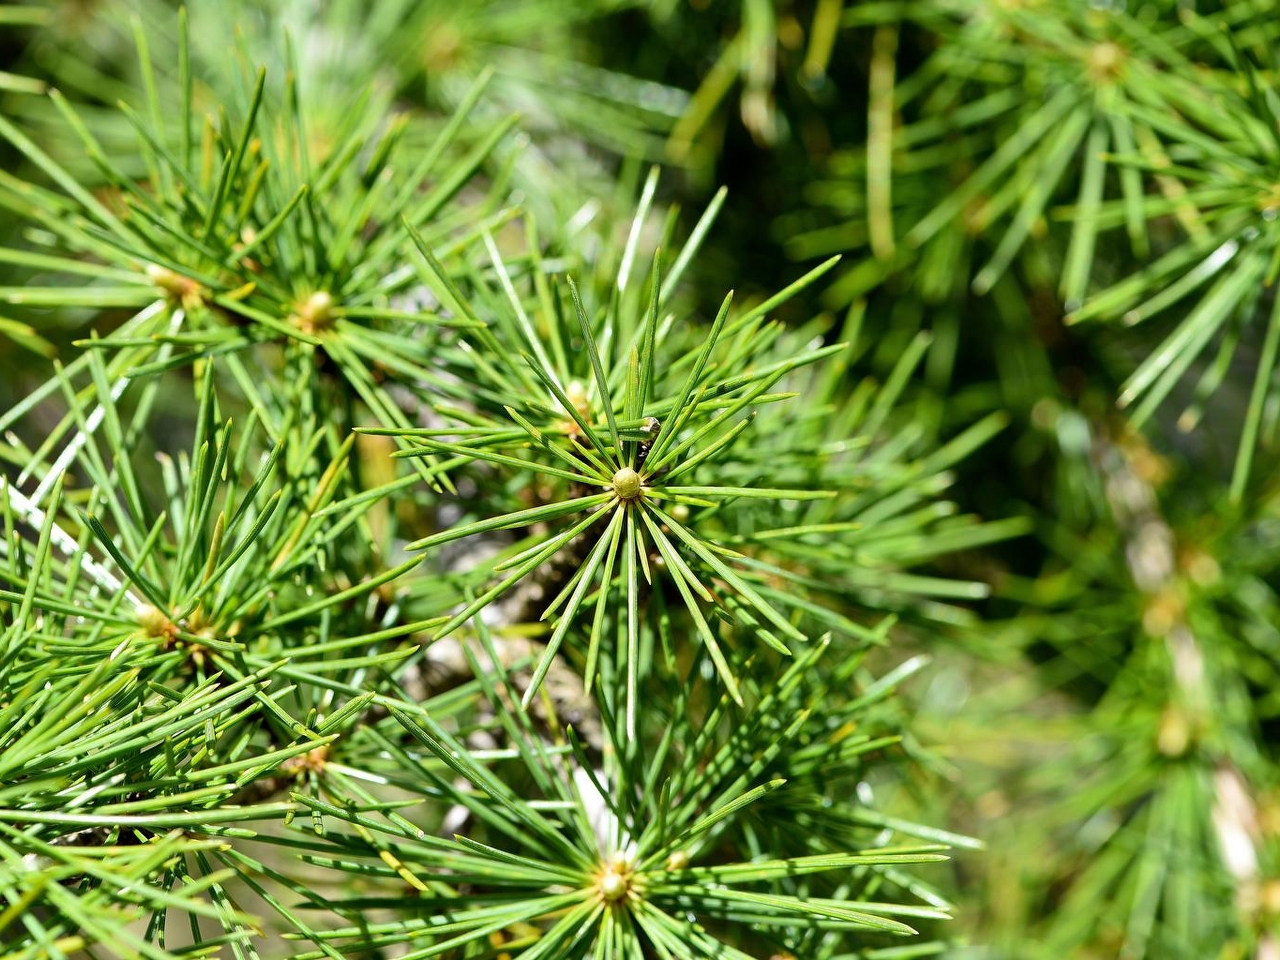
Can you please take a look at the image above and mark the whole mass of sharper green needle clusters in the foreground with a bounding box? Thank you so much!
[0,6,983,957]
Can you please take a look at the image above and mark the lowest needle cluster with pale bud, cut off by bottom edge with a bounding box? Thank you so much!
[270,640,946,957]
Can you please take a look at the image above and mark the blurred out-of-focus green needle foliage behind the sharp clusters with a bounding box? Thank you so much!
[0,0,1280,960]
